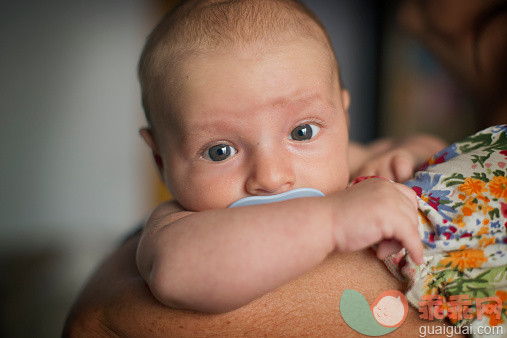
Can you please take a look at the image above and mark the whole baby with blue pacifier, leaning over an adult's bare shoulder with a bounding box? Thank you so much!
[137,0,444,312]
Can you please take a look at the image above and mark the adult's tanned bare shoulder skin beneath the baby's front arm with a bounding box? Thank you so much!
[63,232,458,337]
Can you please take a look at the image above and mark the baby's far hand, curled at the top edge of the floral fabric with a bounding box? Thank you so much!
[357,148,419,182]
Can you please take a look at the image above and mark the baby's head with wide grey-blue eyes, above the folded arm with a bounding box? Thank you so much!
[139,0,349,211]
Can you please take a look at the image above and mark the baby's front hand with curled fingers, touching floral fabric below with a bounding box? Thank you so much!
[329,178,423,264]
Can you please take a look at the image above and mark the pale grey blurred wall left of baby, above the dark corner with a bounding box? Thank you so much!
[0,0,155,248]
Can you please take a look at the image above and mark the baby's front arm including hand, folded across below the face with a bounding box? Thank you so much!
[137,179,422,312]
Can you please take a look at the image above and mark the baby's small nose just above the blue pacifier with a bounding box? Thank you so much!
[246,149,295,195]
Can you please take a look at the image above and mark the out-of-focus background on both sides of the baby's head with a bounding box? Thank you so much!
[0,0,492,337]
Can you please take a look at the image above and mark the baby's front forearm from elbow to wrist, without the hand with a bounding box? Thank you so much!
[137,198,334,312]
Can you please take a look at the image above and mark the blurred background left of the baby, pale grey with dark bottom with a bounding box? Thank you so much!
[0,0,153,337]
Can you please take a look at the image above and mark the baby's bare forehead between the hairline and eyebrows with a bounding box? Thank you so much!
[153,39,340,135]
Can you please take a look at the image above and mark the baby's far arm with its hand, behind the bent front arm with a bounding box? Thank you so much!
[349,134,446,182]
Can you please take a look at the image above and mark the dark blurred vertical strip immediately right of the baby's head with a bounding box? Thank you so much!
[302,0,382,142]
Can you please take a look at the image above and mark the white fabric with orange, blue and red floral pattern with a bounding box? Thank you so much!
[385,125,507,334]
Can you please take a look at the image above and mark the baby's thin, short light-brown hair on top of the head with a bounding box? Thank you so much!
[138,0,339,126]
